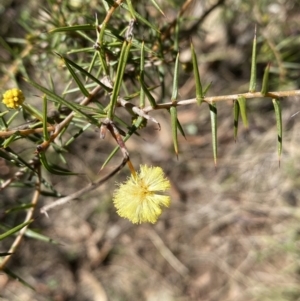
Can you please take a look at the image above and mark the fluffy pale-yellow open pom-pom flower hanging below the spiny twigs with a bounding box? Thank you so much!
[113,165,171,224]
